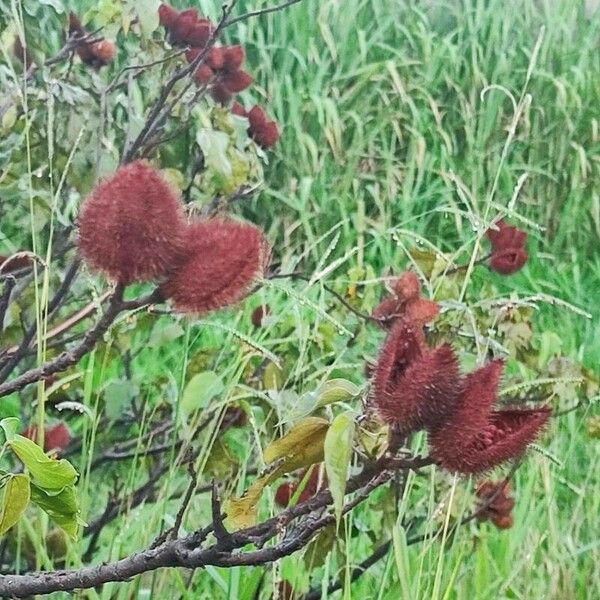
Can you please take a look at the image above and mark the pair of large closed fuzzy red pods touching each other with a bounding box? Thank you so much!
[79,160,270,314]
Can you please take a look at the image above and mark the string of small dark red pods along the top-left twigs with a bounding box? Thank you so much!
[158,4,279,149]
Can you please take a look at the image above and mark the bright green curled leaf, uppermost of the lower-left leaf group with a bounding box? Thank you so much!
[8,435,77,494]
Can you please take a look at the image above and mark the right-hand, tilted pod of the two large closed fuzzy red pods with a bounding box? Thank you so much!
[162,219,270,314]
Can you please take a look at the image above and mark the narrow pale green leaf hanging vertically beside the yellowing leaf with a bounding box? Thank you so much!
[325,413,354,524]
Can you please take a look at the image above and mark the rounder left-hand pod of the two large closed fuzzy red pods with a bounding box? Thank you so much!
[79,160,185,284]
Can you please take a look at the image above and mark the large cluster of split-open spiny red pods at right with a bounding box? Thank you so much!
[372,273,550,474]
